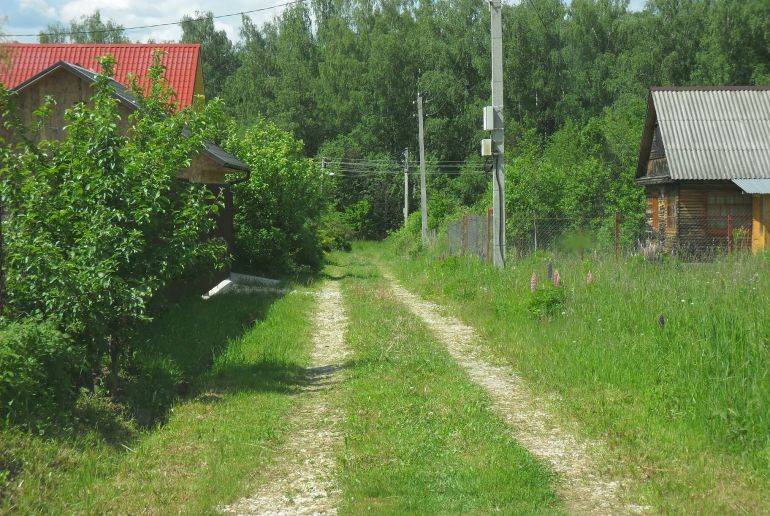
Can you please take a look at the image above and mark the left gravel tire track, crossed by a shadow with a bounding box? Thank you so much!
[220,281,348,515]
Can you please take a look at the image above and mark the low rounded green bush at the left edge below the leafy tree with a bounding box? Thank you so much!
[0,320,85,431]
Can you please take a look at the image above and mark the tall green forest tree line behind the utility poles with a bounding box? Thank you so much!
[36,0,770,237]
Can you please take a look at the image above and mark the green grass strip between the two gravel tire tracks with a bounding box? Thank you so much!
[333,255,560,514]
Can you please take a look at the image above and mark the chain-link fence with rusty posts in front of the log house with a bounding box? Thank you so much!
[442,210,757,261]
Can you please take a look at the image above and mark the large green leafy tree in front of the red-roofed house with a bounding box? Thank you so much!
[0,54,226,389]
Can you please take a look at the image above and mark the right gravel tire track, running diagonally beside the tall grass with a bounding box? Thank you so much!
[383,271,649,514]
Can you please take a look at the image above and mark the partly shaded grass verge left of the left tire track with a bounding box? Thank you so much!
[0,293,314,514]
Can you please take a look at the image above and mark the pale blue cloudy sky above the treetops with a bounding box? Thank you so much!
[0,0,645,43]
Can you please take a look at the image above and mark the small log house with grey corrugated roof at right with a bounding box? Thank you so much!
[636,86,770,254]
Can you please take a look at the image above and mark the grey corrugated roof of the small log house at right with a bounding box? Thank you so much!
[651,87,770,180]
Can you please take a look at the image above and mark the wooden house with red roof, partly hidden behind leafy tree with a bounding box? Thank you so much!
[0,44,249,254]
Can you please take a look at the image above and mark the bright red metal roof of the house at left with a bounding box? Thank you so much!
[0,43,200,108]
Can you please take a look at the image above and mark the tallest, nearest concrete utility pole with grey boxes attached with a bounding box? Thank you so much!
[489,0,505,268]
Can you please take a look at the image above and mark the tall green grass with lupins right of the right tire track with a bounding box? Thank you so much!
[376,240,770,513]
